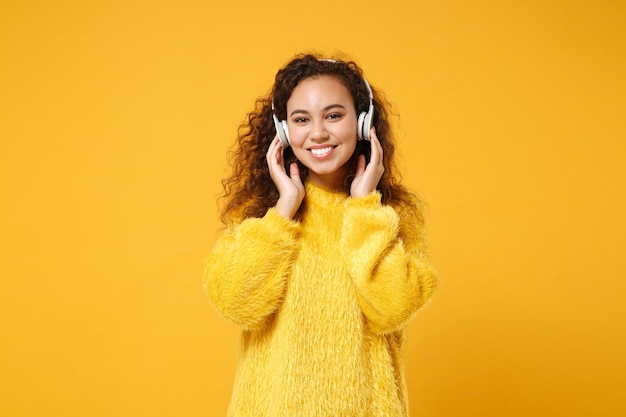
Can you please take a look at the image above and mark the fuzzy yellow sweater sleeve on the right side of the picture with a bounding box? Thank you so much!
[341,191,437,334]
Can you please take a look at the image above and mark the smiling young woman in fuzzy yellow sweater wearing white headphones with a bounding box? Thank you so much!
[204,55,437,417]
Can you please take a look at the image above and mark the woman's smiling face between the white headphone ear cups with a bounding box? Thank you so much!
[287,75,357,189]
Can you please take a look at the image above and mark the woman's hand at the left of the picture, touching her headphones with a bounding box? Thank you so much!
[266,135,304,219]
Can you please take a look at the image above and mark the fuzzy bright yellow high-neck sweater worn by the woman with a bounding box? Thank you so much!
[204,183,437,417]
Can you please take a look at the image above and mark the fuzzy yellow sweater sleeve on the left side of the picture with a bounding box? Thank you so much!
[204,209,299,330]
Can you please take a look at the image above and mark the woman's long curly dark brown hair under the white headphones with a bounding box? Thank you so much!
[220,53,423,224]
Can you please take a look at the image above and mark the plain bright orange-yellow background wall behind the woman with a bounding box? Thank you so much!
[0,0,626,417]
